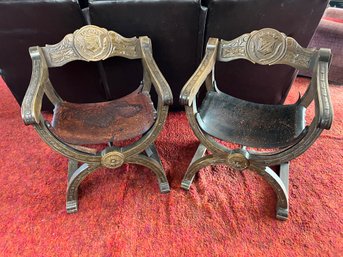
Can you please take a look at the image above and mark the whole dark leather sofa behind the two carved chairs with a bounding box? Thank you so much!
[0,0,328,110]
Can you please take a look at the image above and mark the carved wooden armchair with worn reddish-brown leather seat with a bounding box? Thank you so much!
[21,25,173,213]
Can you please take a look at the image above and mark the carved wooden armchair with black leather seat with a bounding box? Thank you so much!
[180,28,333,220]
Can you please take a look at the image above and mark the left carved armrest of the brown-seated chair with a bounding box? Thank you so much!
[21,46,48,125]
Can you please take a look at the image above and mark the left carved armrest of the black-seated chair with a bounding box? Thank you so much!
[180,38,218,106]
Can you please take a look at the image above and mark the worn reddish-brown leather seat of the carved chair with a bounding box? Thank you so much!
[51,89,156,145]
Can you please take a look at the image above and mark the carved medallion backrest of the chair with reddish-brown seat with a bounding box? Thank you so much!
[42,25,142,67]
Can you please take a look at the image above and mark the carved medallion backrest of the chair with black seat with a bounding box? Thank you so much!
[217,28,317,69]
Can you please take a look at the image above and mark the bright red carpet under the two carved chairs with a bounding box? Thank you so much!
[0,79,343,257]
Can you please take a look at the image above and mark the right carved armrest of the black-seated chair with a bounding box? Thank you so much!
[315,49,333,129]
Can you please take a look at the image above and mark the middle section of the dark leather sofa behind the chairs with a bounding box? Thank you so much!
[89,0,205,110]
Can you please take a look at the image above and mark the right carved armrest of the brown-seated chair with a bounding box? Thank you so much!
[139,37,173,105]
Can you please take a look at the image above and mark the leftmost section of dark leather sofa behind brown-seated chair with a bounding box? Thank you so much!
[0,0,105,110]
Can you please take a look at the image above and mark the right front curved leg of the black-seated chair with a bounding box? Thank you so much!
[250,163,289,220]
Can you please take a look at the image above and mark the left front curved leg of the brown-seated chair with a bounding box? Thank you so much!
[66,162,99,213]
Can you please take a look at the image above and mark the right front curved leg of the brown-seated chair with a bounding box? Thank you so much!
[125,152,170,193]
